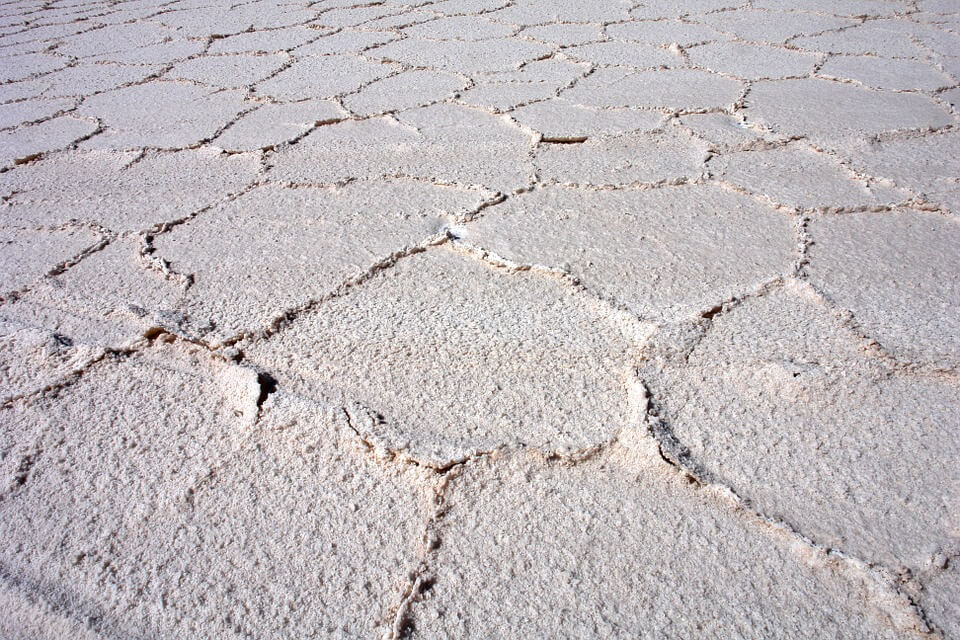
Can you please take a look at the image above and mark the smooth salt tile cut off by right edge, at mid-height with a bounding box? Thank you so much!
[808,211,960,368]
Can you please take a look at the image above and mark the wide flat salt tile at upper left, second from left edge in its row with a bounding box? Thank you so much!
[77,82,244,149]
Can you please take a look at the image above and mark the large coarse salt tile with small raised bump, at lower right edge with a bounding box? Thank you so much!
[640,284,960,569]
